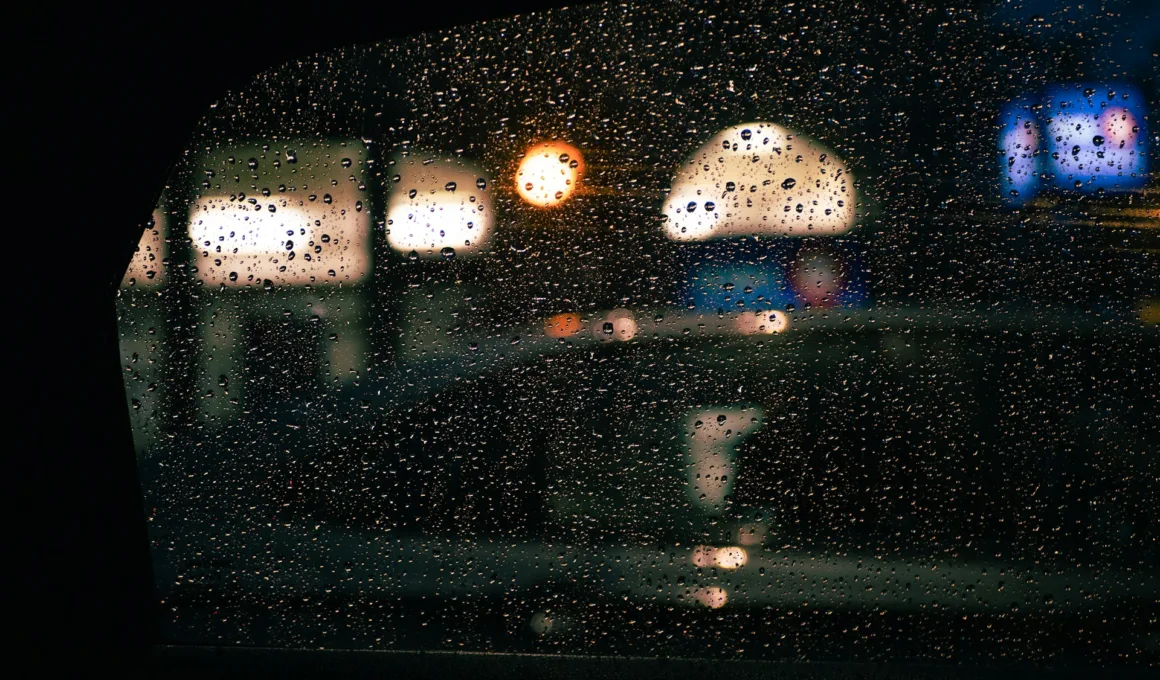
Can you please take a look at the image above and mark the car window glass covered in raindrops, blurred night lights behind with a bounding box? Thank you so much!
[118,2,1160,665]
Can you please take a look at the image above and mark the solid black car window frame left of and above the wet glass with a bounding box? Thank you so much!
[29,0,578,674]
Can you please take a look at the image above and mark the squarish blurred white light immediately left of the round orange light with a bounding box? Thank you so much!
[386,153,492,258]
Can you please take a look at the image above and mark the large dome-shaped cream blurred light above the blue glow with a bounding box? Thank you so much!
[662,122,855,241]
